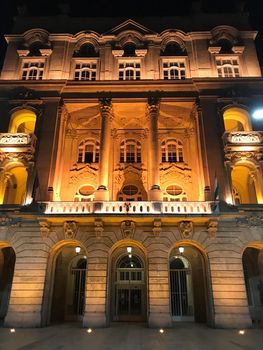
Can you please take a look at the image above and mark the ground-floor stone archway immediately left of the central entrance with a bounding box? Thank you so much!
[42,239,87,326]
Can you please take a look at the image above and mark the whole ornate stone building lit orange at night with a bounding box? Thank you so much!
[0,8,263,328]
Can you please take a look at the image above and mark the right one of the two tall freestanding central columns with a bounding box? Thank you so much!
[148,97,162,201]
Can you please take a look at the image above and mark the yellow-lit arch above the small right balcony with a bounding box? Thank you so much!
[223,106,252,132]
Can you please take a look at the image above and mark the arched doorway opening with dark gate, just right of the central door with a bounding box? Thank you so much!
[169,245,208,322]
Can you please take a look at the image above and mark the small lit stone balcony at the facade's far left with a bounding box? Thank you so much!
[0,133,37,154]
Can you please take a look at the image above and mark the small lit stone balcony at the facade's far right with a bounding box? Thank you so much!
[223,131,263,161]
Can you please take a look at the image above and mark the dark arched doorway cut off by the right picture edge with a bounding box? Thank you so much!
[242,247,263,327]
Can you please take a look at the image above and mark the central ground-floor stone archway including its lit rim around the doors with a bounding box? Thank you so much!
[107,239,148,322]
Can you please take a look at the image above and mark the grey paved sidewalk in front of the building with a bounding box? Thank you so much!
[0,323,263,350]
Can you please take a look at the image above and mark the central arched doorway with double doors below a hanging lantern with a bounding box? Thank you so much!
[111,247,147,322]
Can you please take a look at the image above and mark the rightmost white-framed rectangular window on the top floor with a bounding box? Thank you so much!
[216,56,240,78]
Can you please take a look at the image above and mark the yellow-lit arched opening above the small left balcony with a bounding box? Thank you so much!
[8,109,37,134]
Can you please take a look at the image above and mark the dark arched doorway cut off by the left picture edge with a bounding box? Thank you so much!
[0,247,16,325]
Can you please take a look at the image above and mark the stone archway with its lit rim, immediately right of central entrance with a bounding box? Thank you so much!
[168,240,212,324]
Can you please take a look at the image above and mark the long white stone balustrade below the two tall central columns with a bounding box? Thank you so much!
[43,201,215,215]
